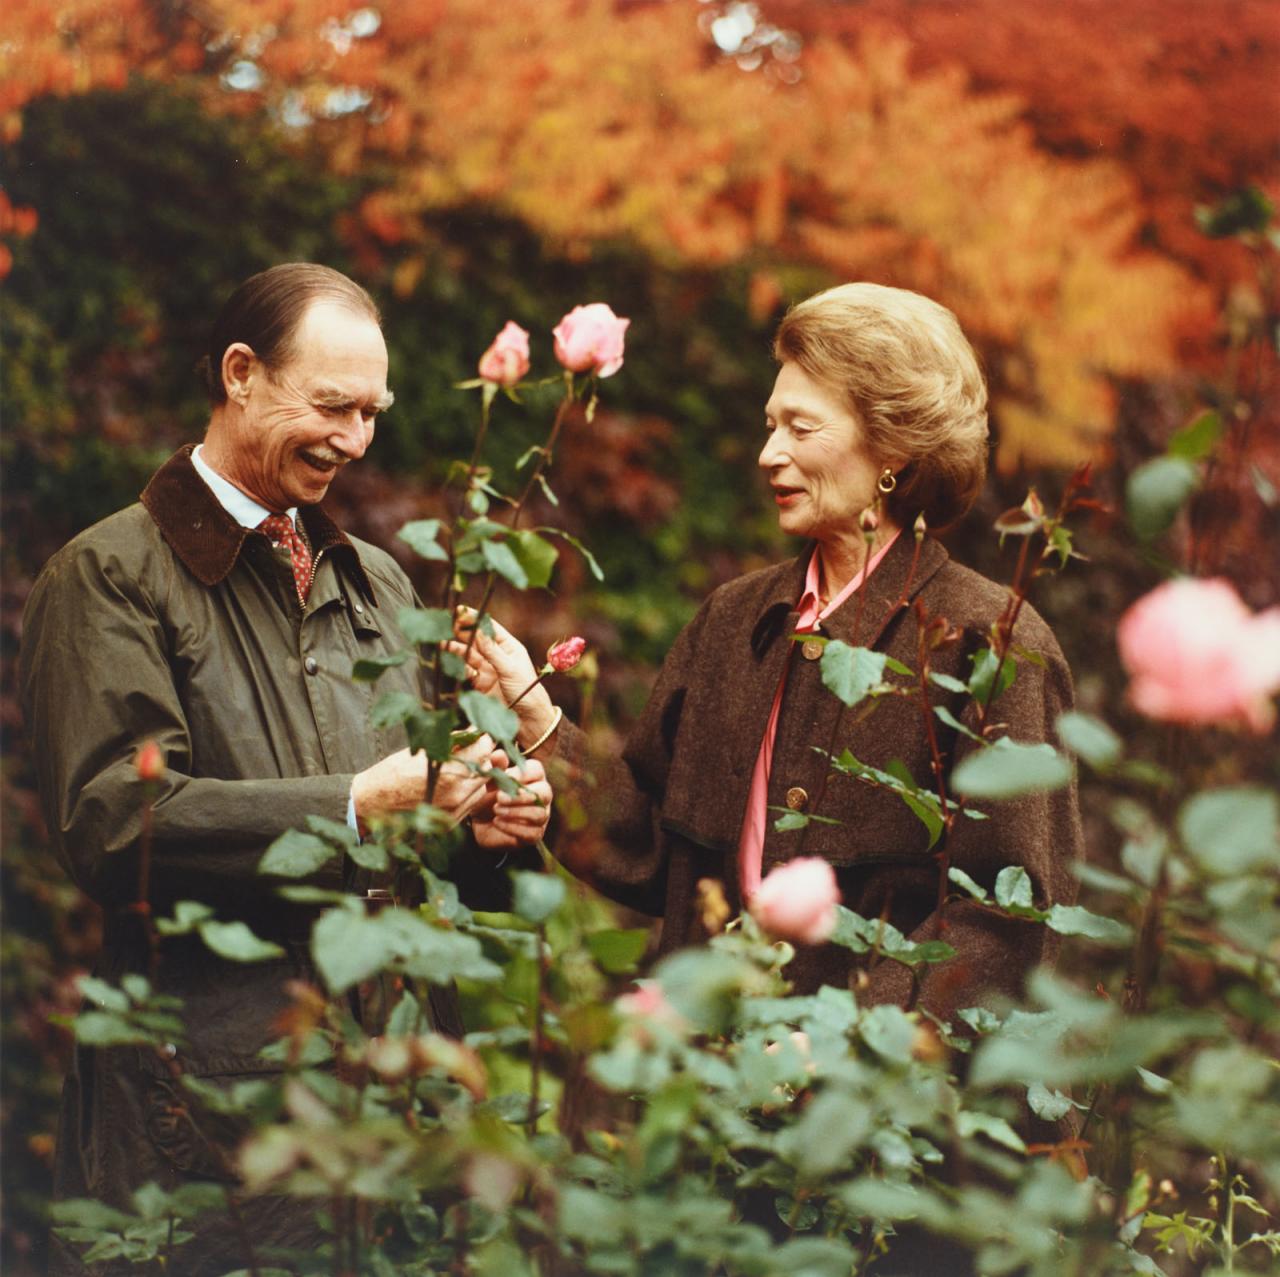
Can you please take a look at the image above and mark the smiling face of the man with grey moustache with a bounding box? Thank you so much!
[218,301,392,511]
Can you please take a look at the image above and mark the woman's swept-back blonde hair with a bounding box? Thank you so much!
[773,284,987,531]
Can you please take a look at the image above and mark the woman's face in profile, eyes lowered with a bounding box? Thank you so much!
[760,363,884,541]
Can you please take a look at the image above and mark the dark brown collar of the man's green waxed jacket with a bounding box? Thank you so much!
[141,444,378,605]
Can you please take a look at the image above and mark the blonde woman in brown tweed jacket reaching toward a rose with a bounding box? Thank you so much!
[460,284,1080,1017]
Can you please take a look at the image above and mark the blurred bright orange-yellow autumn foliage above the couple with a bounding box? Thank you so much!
[0,0,1210,466]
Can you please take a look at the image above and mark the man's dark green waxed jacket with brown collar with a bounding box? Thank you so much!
[19,448,499,1273]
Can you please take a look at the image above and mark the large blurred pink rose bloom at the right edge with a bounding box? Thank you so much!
[1116,577,1280,732]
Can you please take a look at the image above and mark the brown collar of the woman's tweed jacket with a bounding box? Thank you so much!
[751,530,950,658]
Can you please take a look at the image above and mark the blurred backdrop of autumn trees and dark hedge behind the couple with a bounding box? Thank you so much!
[0,0,1280,1274]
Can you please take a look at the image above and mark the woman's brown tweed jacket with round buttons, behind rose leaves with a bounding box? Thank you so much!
[556,534,1082,1017]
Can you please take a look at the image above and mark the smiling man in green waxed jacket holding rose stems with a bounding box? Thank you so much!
[20,264,550,1272]
